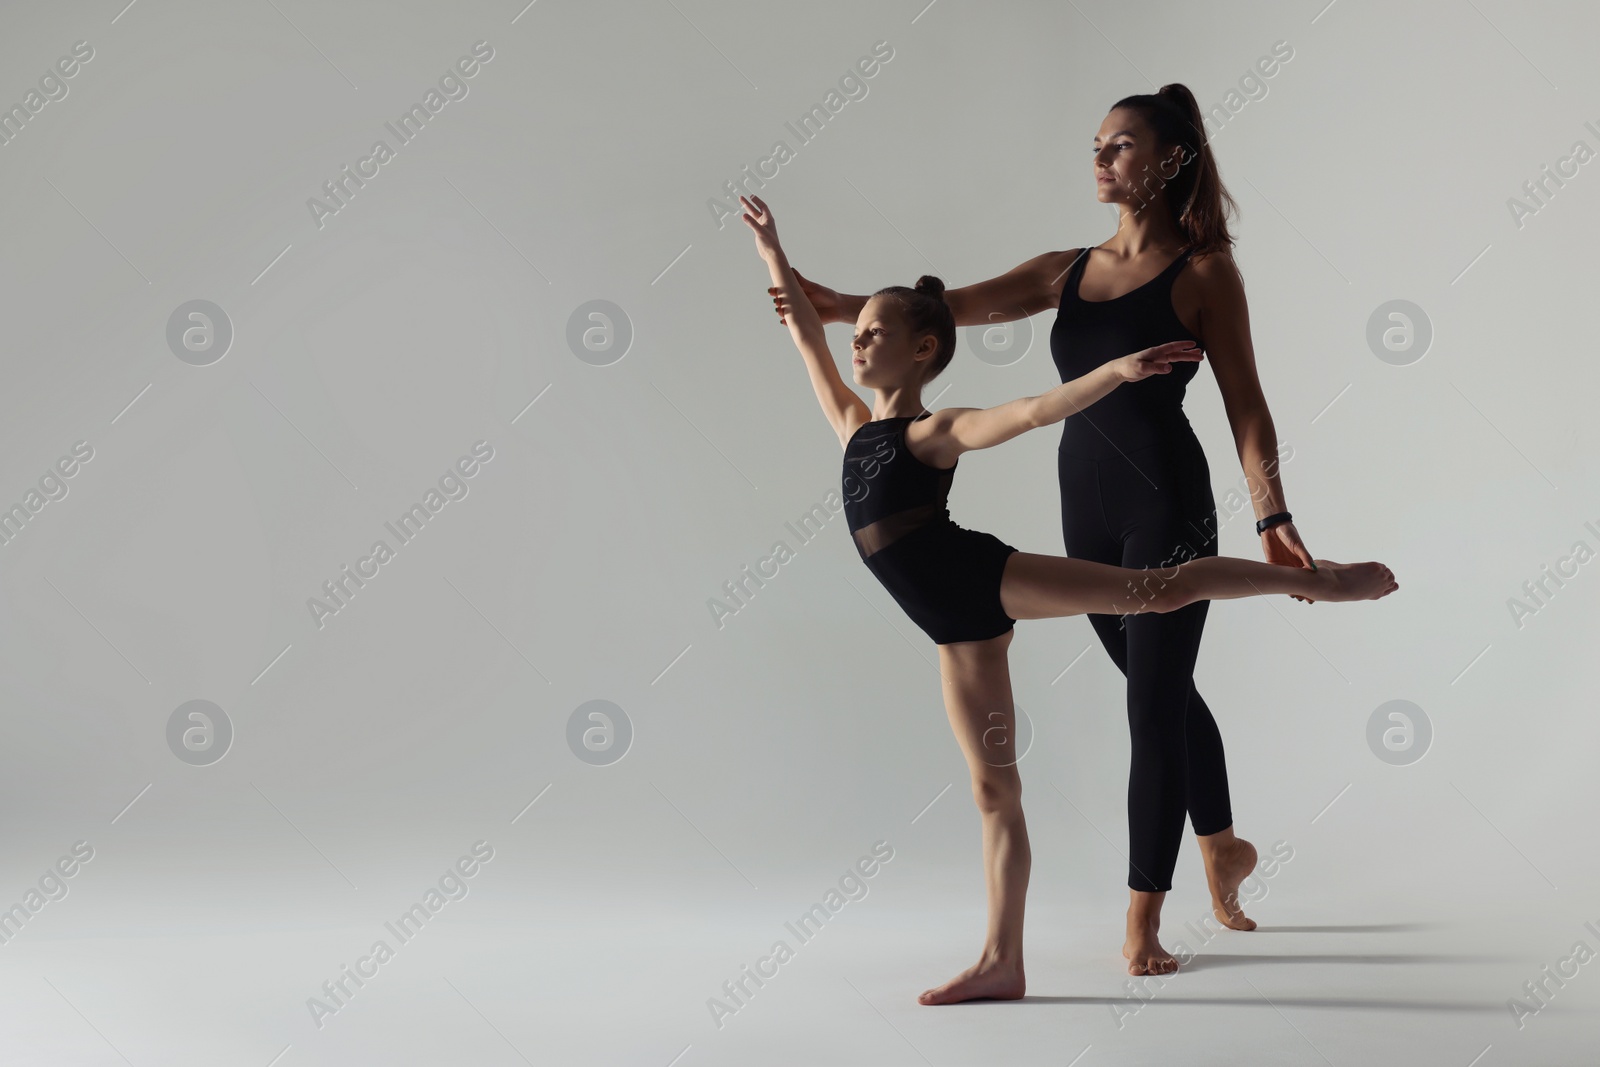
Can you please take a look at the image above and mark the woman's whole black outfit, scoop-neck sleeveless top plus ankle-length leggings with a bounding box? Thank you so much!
[1050,250,1234,893]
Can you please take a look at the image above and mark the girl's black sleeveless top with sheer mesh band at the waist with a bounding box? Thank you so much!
[842,413,960,560]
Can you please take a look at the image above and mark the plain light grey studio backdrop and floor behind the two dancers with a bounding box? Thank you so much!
[0,0,1600,1067]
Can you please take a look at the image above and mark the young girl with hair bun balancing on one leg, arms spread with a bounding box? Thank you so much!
[739,197,1398,1005]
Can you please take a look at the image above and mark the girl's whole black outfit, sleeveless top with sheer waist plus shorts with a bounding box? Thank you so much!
[843,414,1016,645]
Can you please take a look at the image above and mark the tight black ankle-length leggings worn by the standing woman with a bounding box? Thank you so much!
[1058,442,1234,893]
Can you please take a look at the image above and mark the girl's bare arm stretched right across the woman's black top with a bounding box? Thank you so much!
[926,341,1202,466]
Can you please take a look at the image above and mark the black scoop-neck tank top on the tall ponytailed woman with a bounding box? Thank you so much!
[1050,248,1200,459]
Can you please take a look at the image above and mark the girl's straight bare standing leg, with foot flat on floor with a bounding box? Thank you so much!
[917,630,1034,1005]
